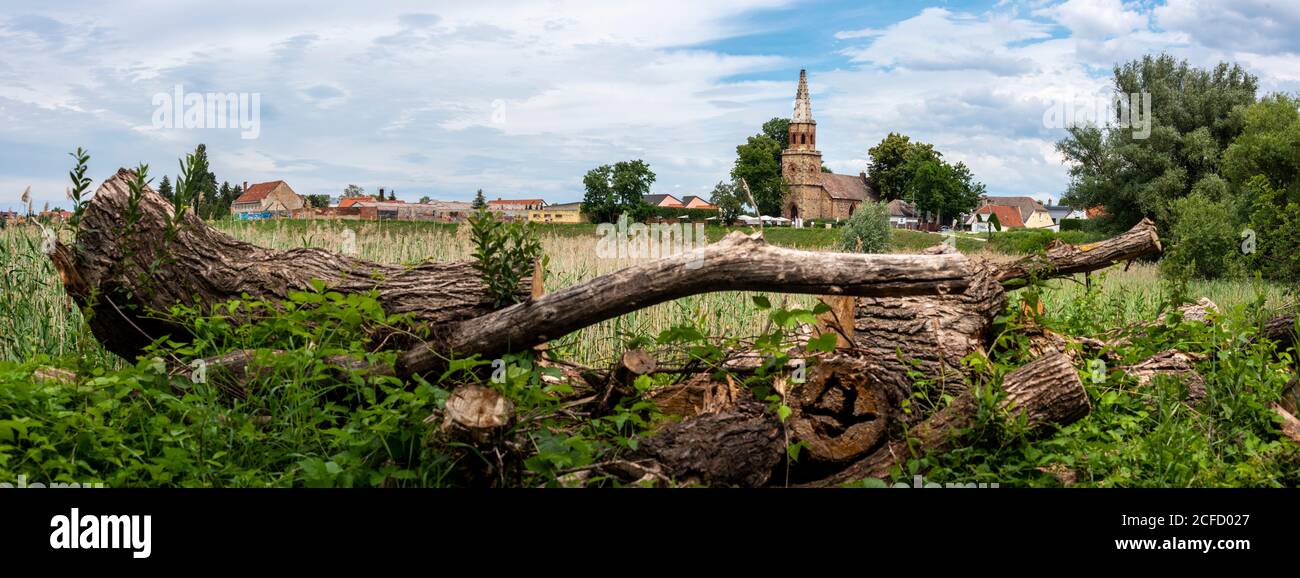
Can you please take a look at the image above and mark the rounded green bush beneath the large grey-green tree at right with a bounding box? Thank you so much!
[1161,194,1243,279]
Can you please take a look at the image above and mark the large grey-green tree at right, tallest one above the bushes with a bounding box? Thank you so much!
[1057,55,1257,231]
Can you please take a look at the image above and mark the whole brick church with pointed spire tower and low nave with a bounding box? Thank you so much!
[781,70,880,221]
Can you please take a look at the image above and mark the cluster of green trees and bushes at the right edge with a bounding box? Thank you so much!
[1057,55,1300,281]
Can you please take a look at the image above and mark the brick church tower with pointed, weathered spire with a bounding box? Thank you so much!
[781,70,826,218]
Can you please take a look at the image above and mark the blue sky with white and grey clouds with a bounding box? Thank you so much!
[0,0,1300,209]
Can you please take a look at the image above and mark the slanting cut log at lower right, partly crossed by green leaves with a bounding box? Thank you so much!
[807,353,1092,486]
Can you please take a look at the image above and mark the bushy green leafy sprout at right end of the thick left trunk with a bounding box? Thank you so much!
[469,209,545,308]
